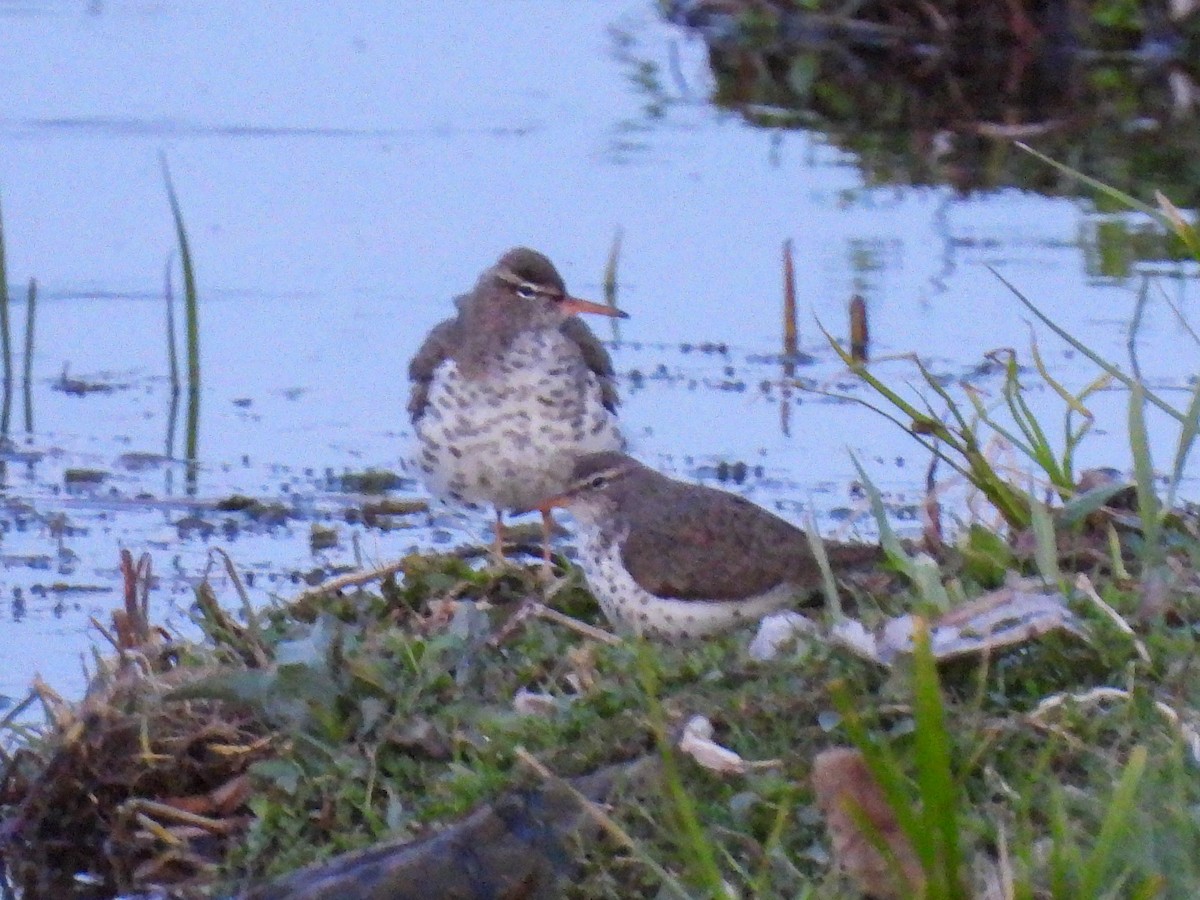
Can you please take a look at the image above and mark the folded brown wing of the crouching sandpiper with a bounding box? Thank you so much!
[622,488,818,600]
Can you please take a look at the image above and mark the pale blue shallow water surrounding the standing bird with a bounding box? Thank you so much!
[0,0,1195,695]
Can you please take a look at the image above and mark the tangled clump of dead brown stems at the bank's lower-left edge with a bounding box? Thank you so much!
[0,551,271,898]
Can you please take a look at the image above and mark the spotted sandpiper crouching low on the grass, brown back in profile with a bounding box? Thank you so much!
[538,451,882,640]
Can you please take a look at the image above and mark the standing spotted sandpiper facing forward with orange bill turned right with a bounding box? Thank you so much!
[408,247,626,565]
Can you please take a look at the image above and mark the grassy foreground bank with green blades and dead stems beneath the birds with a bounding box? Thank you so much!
[0,157,1200,900]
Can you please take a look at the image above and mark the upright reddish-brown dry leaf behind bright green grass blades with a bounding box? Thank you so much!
[812,746,925,900]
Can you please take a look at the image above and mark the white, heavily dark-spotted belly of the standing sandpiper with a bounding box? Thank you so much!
[414,331,623,509]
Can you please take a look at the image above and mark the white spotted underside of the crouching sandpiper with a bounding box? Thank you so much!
[578,526,797,641]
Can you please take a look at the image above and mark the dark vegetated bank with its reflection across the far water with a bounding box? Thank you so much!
[657,1,1200,206]
